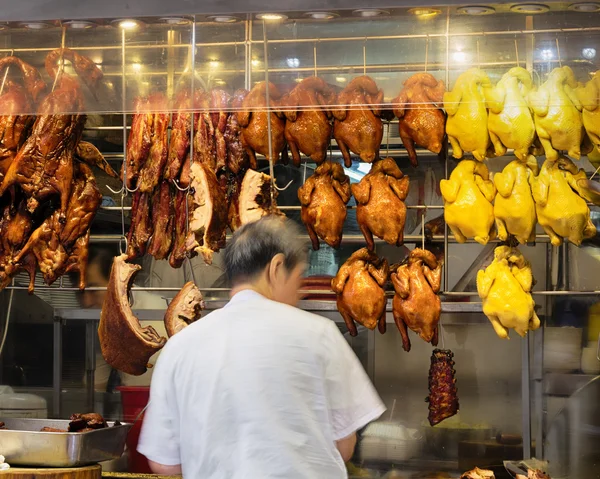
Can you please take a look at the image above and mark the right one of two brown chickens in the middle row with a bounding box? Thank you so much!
[352,158,409,251]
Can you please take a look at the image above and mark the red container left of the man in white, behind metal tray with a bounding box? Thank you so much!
[117,386,152,474]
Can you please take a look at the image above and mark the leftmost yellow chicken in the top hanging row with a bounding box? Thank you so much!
[444,68,491,161]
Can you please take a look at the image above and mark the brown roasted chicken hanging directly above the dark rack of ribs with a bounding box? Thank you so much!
[391,248,442,352]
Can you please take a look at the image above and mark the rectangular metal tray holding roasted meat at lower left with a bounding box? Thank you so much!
[0,418,132,467]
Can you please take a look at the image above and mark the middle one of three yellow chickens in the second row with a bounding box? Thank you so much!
[494,160,537,244]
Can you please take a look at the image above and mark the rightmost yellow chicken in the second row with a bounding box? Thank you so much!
[531,156,596,246]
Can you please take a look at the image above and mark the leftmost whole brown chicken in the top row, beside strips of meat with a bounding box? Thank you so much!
[237,82,285,165]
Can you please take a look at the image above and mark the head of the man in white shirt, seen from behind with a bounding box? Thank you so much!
[225,216,307,305]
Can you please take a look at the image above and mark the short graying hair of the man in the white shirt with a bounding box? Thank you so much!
[225,215,307,285]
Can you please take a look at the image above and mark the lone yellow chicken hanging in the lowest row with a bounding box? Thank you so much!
[477,246,540,339]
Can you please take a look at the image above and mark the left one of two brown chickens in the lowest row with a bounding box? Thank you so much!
[331,248,389,336]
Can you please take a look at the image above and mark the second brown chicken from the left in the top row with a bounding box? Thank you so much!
[282,77,335,166]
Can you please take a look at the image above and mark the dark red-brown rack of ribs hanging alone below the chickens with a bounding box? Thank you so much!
[425,349,458,426]
